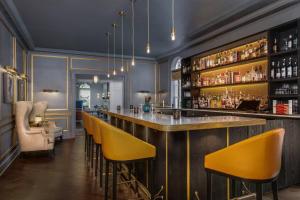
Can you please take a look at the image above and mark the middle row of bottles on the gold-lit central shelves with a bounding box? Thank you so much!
[192,65,267,87]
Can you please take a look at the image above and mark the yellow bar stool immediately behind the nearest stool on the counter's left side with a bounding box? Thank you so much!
[91,116,103,187]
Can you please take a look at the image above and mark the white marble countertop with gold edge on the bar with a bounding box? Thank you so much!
[101,110,266,131]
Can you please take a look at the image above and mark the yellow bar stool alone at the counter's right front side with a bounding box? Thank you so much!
[204,129,285,200]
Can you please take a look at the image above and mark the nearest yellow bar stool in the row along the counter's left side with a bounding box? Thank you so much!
[99,120,156,200]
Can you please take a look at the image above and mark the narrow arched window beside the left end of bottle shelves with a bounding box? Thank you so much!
[171,57,181,108]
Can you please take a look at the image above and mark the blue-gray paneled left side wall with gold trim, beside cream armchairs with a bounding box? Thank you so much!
[0,16,27,175]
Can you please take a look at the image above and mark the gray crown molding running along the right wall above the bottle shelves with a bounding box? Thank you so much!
[156,0,300,63]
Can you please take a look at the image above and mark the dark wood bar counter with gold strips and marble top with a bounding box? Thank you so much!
[100,110,286,200]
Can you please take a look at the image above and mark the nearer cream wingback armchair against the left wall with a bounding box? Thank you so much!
[16,101,54,152]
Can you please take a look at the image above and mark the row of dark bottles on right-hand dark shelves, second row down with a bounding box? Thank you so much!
[270,56,298,79]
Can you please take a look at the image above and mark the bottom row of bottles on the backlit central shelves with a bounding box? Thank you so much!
[192,92,267,109]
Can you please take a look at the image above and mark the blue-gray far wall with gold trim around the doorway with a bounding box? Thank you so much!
[29,52,158,137]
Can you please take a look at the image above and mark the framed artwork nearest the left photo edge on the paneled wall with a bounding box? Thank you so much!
[3,73,14,103]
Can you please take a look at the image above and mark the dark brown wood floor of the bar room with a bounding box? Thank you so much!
[0,136,300,200]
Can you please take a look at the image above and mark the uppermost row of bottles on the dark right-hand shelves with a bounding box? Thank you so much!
[272,31,298,53]
